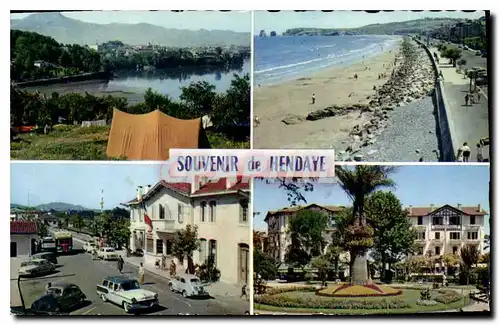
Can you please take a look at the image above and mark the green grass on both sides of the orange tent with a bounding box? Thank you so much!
[10,126,250,160]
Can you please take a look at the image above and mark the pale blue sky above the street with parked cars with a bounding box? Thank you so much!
[10,163,183,209]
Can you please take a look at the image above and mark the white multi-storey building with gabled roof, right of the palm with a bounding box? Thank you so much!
[406,204,488,256]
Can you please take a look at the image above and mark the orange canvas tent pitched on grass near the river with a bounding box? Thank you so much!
[106,109,204,160]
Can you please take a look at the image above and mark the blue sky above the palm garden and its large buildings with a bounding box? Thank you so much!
[253,166,490,234]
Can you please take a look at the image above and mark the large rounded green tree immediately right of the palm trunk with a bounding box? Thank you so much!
[365,191,416,278]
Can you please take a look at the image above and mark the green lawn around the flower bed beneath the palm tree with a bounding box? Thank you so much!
[254,290,469,315]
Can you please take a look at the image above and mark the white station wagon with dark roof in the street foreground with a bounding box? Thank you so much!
[97,276,158,313]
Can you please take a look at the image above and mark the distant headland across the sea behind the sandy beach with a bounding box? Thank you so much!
[283,18,461,36]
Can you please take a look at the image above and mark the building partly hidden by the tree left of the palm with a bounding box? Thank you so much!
[264,204,344,263]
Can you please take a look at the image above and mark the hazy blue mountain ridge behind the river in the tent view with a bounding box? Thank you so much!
[10,12,254,47]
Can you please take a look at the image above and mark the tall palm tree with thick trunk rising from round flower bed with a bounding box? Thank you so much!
[335,166,395,284]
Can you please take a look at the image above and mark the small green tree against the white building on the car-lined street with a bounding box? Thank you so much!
[172,225,200,274]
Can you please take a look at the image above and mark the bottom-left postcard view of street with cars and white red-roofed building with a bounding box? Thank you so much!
[10,163,250,315]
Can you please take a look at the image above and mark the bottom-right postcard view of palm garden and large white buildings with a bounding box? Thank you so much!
[253,165,491,315]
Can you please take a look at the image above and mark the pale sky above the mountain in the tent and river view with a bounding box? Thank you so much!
[11,10,252,33]
